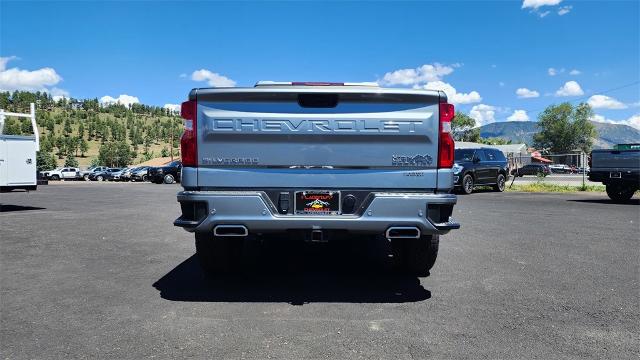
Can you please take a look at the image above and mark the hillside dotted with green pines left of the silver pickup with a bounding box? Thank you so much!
[0,91,182,170]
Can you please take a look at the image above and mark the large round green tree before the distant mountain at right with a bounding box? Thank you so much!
[533,102,597,154]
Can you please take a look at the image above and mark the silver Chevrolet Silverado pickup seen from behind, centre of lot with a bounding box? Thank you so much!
[174,82,460,276]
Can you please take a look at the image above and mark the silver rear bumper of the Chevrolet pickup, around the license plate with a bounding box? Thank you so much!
[174,191,460,235]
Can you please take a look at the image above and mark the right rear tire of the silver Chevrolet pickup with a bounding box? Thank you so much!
[391,235,440,277]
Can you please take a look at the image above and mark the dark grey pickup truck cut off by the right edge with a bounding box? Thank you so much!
[589,145,640,202]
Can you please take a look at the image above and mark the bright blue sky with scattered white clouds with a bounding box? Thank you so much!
[0,0,640,128]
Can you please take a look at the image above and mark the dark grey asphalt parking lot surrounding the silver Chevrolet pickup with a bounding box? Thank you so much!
[0,183,640,359]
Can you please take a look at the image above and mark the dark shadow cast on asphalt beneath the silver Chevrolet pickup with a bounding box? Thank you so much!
[153,238,431,305]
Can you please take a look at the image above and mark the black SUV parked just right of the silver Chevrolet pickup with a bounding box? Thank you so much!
[453,148,509,194]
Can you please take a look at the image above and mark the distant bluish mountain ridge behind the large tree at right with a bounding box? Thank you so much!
[480,121,640,149]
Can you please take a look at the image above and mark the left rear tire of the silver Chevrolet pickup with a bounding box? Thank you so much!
[196,233,244,276]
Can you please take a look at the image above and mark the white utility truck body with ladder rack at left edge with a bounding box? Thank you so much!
[0,103,40,191]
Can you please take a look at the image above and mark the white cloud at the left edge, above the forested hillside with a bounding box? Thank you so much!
[0,56,62,92]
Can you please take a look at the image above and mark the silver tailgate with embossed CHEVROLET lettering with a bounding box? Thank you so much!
[192,88,448,189]
